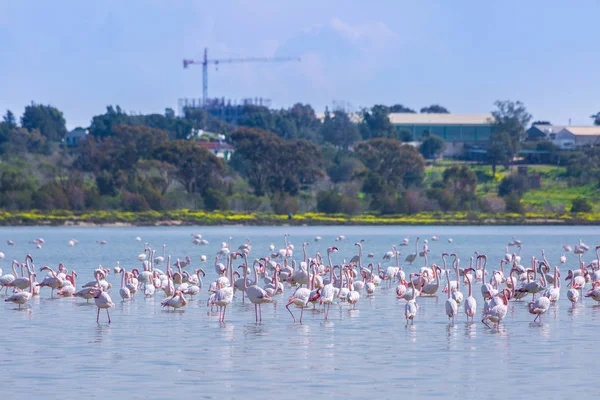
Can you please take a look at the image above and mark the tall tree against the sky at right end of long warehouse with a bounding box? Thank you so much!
[492,100,531,165]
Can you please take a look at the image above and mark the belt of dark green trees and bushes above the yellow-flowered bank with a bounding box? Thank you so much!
[0,101,600,214]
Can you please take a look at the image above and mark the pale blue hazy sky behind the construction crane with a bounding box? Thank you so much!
[0,0,600,128]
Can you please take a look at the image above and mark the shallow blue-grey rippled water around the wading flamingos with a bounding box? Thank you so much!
[0,226,600,399]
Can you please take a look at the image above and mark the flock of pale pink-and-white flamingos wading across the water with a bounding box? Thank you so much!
[0,234,600,328]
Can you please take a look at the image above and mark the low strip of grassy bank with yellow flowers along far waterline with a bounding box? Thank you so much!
[0,210,600,226]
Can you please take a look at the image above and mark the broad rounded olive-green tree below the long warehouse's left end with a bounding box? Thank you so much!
[356,138,425,192]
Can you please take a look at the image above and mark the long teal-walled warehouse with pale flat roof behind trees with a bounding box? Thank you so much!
[390,113,494,156]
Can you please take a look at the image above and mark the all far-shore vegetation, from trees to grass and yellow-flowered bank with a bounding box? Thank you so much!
[0,101,600,225]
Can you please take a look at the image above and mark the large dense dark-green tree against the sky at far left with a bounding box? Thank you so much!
[21,103,67,141]
